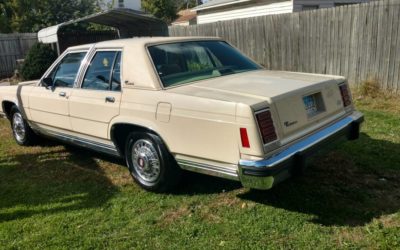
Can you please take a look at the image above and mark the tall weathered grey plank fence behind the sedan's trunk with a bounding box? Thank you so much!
[169,0,400,91]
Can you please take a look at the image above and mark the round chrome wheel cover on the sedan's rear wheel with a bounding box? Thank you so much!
[132,139,160,182]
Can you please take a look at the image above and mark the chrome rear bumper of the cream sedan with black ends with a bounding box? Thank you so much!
[239,111,364,190]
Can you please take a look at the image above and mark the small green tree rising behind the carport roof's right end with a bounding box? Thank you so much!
[142,0,177,23]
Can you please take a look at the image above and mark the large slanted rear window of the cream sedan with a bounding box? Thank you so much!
[148,41,261,88]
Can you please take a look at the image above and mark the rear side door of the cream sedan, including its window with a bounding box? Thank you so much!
[69,50,122,139]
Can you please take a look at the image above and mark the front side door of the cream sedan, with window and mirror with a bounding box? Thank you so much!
[29,51,87,130]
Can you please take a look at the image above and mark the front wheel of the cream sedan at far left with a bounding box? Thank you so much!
[10,106,37,146]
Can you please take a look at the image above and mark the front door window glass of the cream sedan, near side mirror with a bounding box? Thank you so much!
[49,52,86,88]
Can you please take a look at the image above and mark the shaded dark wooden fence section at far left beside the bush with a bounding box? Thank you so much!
[0,33,37,78]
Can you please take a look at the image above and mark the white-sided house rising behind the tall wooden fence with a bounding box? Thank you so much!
[193,0,371,24]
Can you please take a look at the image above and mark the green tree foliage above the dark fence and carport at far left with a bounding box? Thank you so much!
[0,0,98,33]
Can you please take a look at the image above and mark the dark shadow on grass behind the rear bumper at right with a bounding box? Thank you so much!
[238,134,400,226]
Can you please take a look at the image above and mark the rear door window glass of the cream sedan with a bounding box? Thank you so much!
[82,51,121,91]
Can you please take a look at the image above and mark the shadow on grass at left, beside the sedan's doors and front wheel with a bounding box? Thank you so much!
[0,141,118,223]
